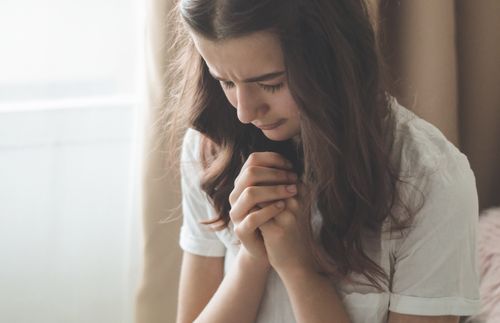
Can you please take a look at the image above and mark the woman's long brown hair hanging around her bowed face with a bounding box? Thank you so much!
[164,0,422,288]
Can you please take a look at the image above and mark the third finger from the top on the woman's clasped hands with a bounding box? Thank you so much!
[229,185,297,223]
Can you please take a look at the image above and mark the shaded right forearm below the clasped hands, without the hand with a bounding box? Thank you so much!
[280,271,350,323]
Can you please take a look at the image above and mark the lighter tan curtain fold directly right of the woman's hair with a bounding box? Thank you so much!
[380,0,459,145]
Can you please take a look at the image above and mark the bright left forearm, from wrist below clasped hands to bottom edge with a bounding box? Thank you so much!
[194,249,271,323]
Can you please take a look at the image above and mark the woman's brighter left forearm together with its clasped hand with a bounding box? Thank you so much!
[188,152,296,323]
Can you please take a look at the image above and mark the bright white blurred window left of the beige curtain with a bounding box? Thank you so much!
[0,0,144,323]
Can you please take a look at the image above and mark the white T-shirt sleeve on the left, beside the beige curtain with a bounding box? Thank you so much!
[179,129,225,257]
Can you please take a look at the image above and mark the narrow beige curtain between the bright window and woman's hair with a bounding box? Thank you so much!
[135,0,182,323]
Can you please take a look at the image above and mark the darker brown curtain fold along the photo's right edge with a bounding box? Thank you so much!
[457,0,500,209]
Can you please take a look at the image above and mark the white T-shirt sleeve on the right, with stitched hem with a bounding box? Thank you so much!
[389,154,480,316]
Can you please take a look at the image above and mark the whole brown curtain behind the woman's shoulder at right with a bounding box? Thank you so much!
[373,0,500,209]
